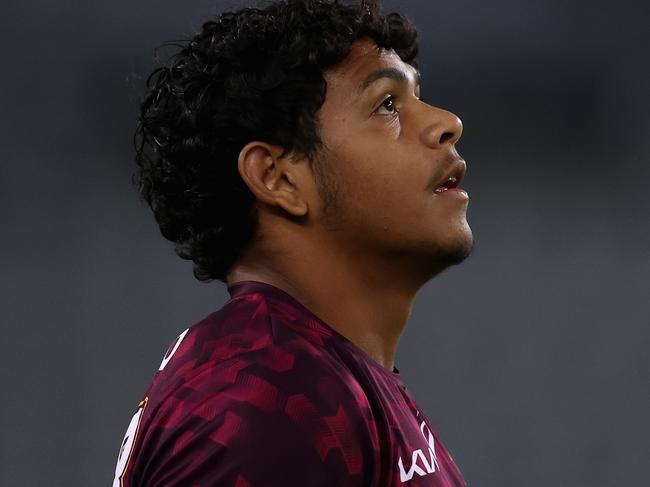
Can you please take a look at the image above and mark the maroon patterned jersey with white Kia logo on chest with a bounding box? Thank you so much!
[113,281,466,487]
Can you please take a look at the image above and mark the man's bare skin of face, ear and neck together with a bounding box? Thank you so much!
[227,39,472,371]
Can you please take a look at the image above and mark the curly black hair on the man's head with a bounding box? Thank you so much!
[134,0,418,283]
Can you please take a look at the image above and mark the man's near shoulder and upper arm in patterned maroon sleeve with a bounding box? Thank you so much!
[123,299,378,486]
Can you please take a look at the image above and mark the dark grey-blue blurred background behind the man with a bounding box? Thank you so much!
[0,0,650,487]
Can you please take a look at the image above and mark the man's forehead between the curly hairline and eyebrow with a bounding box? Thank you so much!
[323,38,416,98]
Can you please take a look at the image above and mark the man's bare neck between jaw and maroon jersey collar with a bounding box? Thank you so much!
[227,228,432,371]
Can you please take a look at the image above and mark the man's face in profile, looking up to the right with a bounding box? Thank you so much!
[316,39,472,272]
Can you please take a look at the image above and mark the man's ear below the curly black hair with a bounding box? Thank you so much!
[237,141,309,216]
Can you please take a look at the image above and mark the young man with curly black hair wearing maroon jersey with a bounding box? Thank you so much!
[113,0,472,487]
